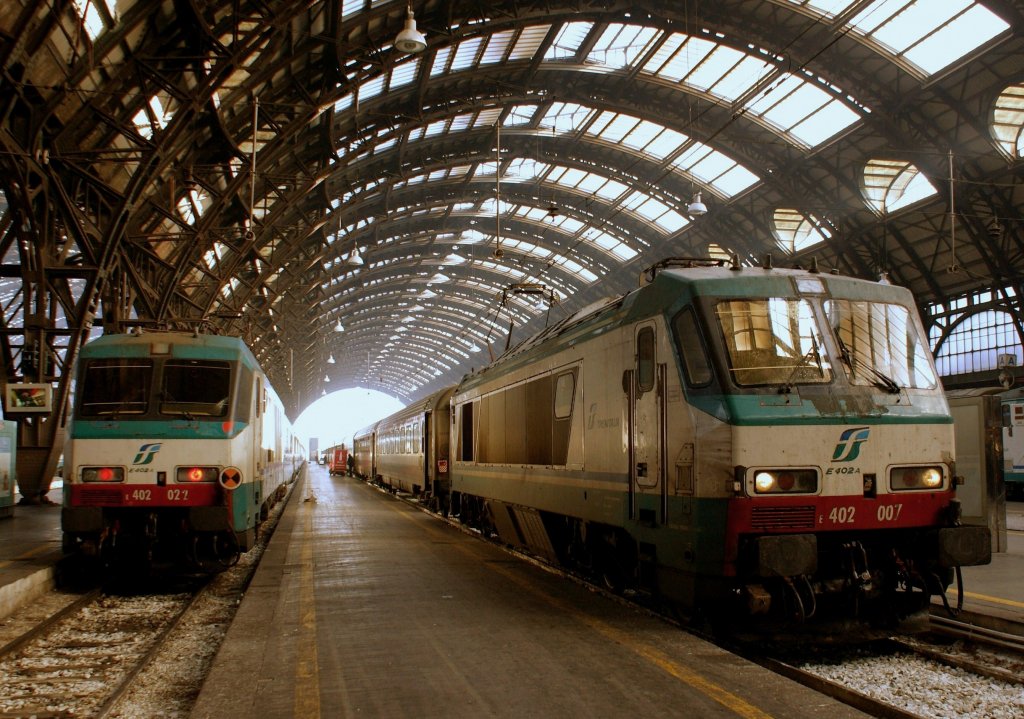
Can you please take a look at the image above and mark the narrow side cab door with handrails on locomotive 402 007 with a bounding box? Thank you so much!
[629,323,668,523]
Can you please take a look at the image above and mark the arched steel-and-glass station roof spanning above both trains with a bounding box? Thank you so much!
[0,0,1024,428]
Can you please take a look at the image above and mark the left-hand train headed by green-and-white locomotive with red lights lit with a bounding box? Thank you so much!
[61,332,304,569]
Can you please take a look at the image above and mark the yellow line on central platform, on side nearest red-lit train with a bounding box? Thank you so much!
[295,474,321,719]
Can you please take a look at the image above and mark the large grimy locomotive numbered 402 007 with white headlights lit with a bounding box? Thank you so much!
[451,258,990,632]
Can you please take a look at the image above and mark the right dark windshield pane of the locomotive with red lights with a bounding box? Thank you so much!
[160,360,231,419]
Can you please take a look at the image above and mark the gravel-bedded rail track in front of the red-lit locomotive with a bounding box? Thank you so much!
[0,583,205,718]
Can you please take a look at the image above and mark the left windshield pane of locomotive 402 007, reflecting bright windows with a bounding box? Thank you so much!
[716,297,833,386]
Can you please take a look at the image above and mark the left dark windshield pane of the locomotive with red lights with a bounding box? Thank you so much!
[79,358,153,417]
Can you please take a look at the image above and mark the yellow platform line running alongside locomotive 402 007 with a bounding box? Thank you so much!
[399,512,772,719]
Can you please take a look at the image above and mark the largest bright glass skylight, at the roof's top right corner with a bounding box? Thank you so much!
[851,0,1010,75]
